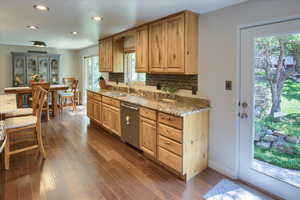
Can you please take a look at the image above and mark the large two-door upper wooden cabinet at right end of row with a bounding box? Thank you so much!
[149,11,198,74]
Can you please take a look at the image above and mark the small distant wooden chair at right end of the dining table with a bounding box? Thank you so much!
[58,80,79,111]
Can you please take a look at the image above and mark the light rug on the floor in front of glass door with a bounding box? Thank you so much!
[203,179,271,200]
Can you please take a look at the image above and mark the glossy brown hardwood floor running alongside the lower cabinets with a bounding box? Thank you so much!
[0,107,230,200]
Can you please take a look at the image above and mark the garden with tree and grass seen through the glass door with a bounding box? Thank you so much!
[254,34,300,170]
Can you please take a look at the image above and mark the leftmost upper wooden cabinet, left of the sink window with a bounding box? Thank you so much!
[99,38,113,72]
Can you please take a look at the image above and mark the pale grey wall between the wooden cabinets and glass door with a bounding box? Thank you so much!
[199,0,300,176]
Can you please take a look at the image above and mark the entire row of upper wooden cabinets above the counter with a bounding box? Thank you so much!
[99,11,199,74]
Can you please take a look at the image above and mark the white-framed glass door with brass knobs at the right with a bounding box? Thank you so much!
[238,20,300,200]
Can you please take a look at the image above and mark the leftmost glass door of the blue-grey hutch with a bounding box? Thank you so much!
[13,55,26,87]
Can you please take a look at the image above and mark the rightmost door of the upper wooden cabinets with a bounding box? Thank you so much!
[165,14,184,73]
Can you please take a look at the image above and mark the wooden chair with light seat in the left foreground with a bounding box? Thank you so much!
[4,86,48,170]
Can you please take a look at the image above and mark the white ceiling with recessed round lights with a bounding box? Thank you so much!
[0,0,247,49]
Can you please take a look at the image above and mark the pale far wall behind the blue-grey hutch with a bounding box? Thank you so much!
[0,45,80,93]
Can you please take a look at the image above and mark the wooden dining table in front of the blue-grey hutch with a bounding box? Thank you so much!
[4,85,69,117]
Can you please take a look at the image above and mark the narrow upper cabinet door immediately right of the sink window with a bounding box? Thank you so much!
[135,26,148,72]
